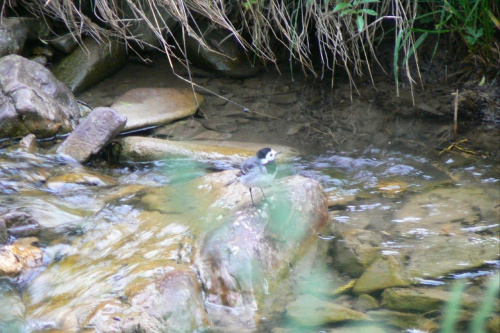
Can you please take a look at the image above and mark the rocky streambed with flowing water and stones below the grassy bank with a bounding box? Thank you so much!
[0,24,500,332]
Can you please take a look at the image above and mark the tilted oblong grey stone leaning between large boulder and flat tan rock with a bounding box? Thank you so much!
[57,107,127,163]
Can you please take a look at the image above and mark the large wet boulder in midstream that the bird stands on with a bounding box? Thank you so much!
[195,171,328,329]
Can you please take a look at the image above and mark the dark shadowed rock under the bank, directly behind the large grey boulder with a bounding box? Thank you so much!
[52,38,127,93]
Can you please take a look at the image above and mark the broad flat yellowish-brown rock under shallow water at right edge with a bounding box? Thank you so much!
[393,188,500,279]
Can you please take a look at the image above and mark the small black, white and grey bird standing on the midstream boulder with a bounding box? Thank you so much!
[225,148,280,205]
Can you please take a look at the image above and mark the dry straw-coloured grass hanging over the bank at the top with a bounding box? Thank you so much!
[8,0,418,94]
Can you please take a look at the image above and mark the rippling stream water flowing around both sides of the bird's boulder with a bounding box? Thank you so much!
[0,58,500,332]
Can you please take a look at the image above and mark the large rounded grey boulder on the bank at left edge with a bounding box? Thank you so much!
[0,55,80,138]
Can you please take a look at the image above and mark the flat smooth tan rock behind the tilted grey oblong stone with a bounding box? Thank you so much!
[111,88,203,131]
